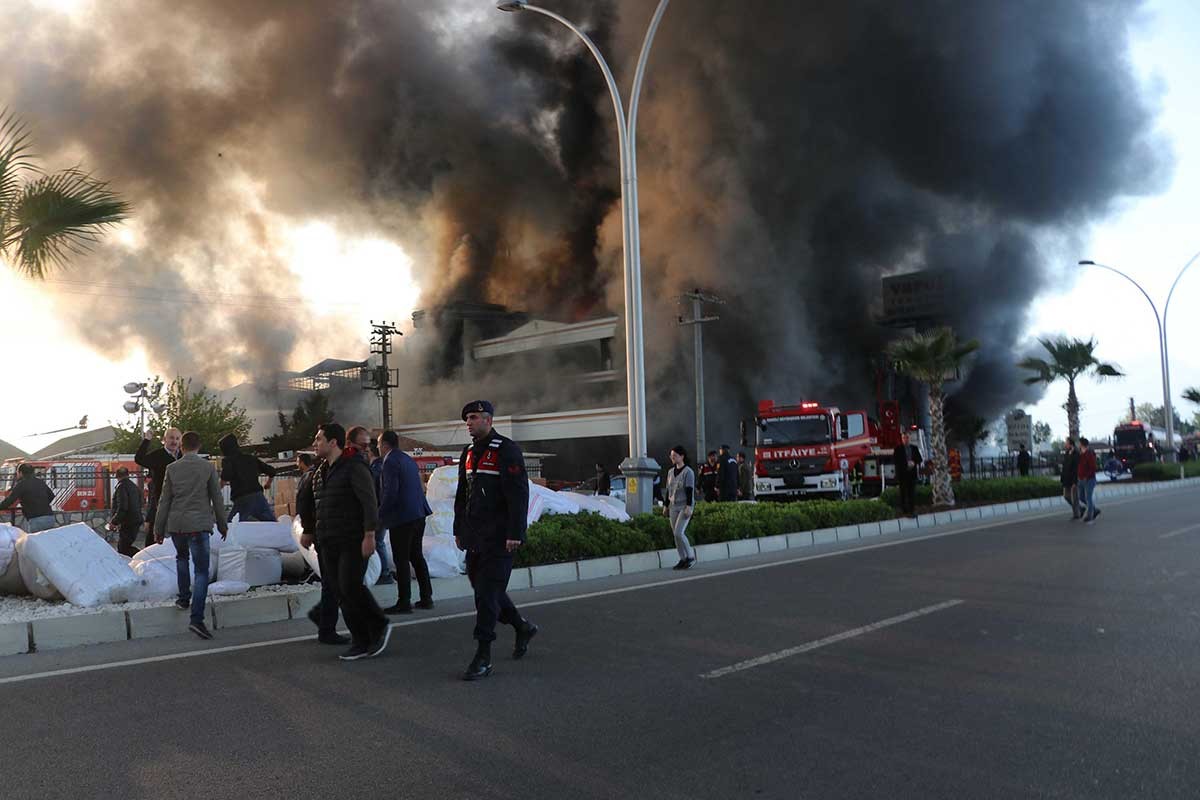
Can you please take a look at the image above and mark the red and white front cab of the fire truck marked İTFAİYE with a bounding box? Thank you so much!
[754,401,875,500]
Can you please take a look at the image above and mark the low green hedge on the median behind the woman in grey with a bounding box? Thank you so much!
[515,500,895,566]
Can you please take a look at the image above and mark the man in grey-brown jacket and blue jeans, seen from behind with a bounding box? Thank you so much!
[154,431,229,639]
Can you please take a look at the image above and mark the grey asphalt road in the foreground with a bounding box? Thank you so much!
[0,491,1200,800]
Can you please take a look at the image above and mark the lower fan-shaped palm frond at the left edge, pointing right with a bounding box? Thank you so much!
[0,169,130,278]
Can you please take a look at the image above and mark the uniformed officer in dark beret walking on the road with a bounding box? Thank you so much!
[454,401,538,680]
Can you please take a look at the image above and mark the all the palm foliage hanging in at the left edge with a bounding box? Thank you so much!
[0,108,130,278]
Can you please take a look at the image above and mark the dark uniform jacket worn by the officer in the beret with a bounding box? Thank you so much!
[454,431,529,553]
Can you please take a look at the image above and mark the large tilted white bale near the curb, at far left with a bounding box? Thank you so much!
[22,523,138,607]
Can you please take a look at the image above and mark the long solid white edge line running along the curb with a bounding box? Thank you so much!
[0,495,1190,685]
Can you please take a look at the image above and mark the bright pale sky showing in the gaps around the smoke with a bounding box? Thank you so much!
[0,0,1200,451]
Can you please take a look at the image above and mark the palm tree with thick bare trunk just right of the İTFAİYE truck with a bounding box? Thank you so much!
[888,327,979,506]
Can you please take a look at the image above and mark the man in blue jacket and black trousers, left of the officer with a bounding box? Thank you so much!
[372,431,433,614]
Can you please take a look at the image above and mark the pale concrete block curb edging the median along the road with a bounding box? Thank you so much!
[0,477,1200,656]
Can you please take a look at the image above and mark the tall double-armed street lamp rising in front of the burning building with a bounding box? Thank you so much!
[496,0,670,515]
